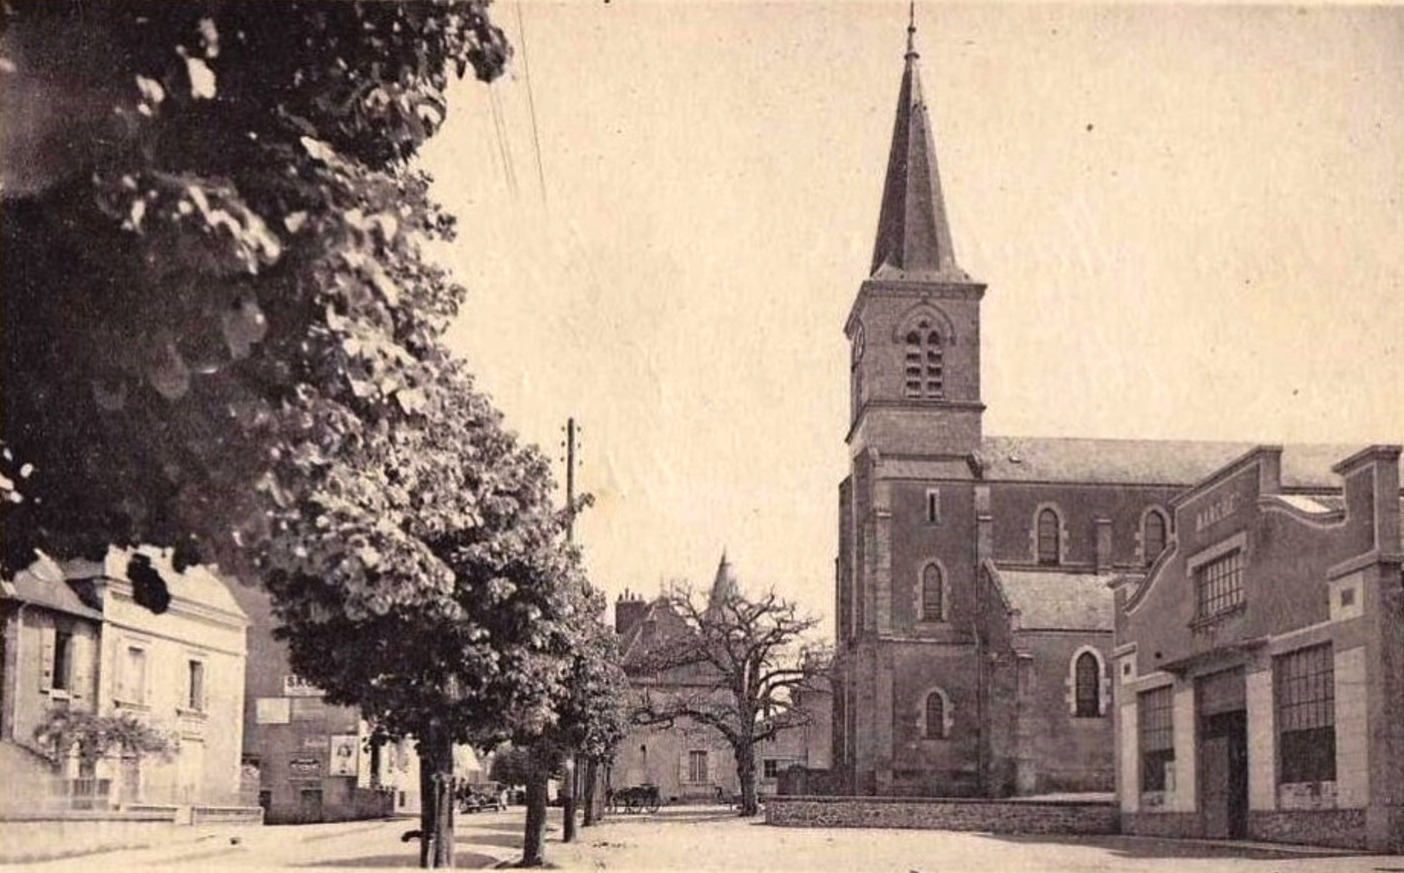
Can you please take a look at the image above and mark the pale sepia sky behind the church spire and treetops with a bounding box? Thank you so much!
[423,0,1404,633]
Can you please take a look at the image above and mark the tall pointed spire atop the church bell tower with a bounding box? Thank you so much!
[872,0,969,282]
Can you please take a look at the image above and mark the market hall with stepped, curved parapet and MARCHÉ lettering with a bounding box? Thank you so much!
[1113,446,1404,852]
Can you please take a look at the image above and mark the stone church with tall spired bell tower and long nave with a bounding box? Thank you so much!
[833,15,1387,797]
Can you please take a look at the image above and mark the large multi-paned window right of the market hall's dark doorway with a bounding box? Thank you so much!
[1272,643,1335,783]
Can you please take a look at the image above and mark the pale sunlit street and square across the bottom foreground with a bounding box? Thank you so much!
[17,807,1404,873]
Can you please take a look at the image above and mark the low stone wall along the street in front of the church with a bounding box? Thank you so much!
[765,797,1120,834]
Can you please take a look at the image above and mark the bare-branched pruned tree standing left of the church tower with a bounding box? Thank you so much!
[628,588,826,815]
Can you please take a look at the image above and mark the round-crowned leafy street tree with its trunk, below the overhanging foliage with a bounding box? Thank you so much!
[265,361,585,866]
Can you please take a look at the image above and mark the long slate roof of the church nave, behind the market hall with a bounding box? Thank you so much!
[980,437,1365,488]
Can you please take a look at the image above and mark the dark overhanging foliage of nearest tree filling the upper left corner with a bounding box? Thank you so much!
[0,0,508,600]
